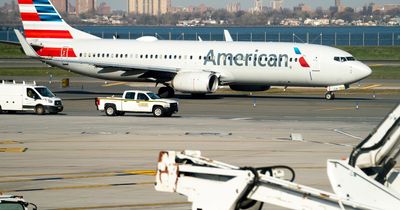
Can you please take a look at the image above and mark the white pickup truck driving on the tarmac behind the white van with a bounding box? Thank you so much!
[96,90,178,117]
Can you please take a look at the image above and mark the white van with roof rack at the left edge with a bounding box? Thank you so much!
[0,80,64,115]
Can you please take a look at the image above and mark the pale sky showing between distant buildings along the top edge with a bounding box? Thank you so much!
[0,0,399,9]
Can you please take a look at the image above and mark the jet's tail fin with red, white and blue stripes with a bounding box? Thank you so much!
[18,0,99,43]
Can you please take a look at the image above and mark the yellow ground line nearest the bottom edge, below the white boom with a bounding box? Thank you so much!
[50,202,190,210]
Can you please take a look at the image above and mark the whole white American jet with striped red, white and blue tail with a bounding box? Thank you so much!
[15,0,371,99]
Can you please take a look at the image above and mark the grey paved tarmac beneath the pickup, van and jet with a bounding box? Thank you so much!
[0,78,400,210]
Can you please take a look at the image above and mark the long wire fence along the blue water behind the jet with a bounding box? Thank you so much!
[0,31,400,46]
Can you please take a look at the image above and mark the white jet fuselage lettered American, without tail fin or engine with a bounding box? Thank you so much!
[46,39,371,87]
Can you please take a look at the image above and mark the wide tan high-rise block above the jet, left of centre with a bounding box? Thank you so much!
[128,0,171,16]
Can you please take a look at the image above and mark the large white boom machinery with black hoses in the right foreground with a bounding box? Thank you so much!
[155,105,400,210]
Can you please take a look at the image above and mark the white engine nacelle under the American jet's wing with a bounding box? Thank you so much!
[172,72,218,93]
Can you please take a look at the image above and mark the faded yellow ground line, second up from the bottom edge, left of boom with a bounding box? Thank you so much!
[0,182,155,193]
